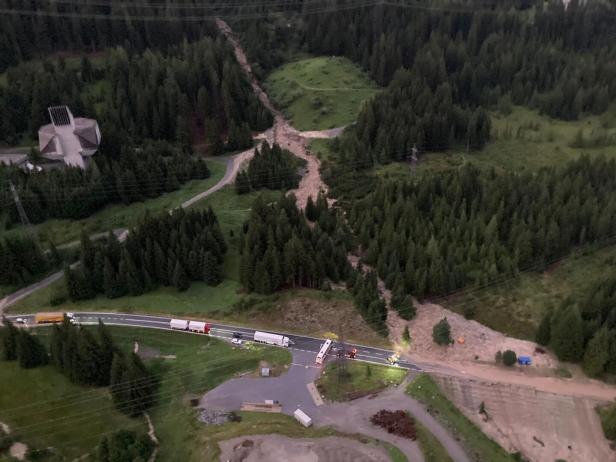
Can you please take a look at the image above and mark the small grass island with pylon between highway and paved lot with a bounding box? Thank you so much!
[316,361,406,401]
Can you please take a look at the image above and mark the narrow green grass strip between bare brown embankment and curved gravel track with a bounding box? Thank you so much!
[406,374,516,462]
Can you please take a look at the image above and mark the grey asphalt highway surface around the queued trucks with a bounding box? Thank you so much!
[7,312,422,371]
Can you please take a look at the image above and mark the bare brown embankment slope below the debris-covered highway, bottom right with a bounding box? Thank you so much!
[433,375,616,462]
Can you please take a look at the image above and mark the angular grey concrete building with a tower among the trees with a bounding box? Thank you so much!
[39,106,101,169]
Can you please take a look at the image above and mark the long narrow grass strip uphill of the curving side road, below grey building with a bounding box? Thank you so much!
[0,160,226,245]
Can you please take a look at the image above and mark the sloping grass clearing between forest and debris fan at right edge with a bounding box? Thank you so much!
[443,246,616,340]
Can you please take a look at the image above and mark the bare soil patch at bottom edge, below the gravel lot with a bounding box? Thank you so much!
[219,435,390,462]
